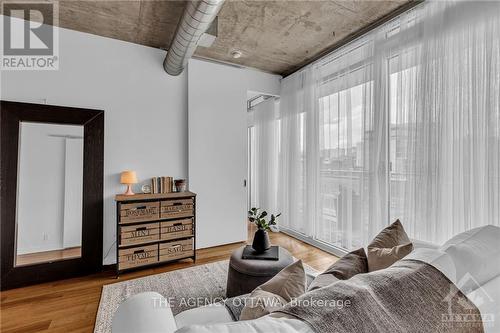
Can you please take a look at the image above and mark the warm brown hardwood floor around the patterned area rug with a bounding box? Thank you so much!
[0,223,337,333]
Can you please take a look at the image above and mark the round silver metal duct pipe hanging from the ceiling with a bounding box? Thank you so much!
[163,0,224,76]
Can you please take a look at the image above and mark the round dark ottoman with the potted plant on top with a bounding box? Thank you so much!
[226,246,293,298]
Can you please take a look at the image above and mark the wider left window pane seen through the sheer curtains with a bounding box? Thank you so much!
[316,84,369,248]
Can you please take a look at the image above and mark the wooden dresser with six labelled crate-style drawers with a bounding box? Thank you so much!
[115,192,196,275]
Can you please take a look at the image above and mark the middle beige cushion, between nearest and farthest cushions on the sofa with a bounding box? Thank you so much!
[307,248,368,291]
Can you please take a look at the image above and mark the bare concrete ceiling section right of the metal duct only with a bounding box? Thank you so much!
[196,0,408,75]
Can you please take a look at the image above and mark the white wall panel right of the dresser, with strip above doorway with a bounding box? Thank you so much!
[188,60,280,248]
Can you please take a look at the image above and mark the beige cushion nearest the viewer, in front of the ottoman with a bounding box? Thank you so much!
[240,260,306,320]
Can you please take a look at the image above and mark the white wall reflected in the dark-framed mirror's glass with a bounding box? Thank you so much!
[16,122,83,254]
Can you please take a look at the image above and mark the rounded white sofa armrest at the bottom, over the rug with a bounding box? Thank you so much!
[112,292,177,333]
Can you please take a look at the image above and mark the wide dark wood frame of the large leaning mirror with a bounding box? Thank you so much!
[0,101,104,290]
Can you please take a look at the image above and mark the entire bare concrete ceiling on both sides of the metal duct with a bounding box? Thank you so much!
[4,0,408,75]
